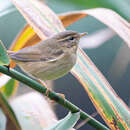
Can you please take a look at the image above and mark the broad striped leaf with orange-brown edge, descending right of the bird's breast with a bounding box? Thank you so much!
[71,49,130,130]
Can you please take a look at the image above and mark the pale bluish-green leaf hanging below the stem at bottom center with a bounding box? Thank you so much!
[45,112,80,130]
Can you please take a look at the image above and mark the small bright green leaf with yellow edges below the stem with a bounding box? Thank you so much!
[0,79,18,98]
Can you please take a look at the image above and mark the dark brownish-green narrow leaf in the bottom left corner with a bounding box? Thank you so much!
[0,92,21,130]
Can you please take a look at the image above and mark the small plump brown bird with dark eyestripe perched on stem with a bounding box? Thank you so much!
[8,31,86,81]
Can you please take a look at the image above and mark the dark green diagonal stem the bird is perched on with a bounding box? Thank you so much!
[0,66,109,130]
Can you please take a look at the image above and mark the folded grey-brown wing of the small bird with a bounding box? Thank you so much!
[9,47,64,62]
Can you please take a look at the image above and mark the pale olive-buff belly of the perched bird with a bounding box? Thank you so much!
[18,53,76,81]
